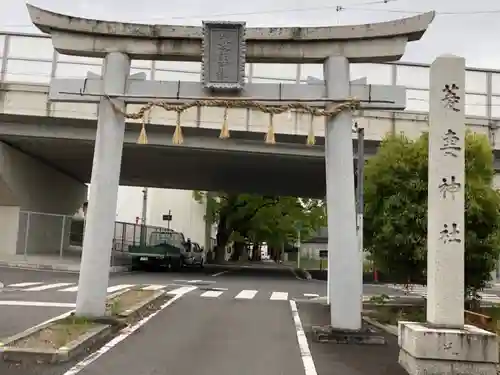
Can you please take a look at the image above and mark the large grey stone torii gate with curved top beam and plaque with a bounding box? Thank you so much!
[28,5,434,331]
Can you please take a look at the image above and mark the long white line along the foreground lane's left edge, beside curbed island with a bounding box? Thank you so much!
[63,286,196,375]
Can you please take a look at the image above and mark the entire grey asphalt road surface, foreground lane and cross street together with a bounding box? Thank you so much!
[0,267,414,375]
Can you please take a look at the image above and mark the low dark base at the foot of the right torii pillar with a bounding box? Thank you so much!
[312,326,386,345]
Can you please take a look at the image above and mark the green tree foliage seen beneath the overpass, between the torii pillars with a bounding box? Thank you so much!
[193,192,326,260]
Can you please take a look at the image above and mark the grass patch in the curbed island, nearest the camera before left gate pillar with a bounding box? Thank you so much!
[10,316,99,350]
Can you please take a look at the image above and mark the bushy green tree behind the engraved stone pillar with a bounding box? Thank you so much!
[364,132,500,296]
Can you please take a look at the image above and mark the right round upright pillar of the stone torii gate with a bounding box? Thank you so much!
[324,56,363,331]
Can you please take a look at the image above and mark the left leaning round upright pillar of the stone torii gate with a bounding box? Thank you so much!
[76,52,130,317]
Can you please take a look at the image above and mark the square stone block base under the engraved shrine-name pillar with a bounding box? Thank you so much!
[398,322,498,375]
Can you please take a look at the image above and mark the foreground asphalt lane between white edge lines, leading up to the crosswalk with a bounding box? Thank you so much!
[65,295,304,375]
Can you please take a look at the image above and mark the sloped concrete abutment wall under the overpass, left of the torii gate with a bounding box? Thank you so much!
[0,143,87,255]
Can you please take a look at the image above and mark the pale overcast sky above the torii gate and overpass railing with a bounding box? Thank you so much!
[0,0,500,69]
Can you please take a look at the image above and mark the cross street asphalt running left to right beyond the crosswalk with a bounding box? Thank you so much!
[0,267,422,303]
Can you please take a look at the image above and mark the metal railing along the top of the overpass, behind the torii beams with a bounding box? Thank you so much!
[0,33,500,119]
